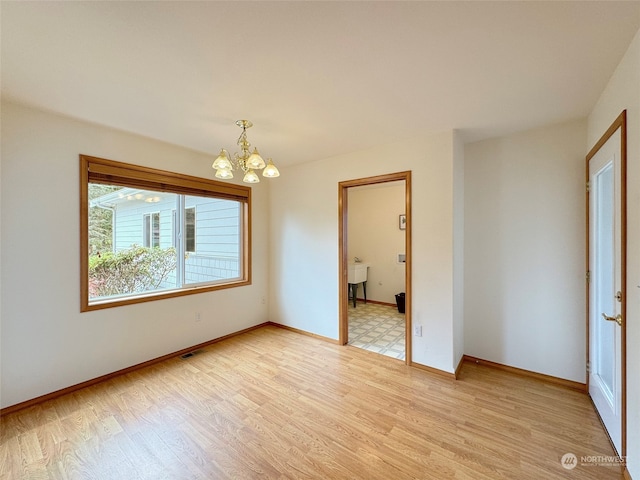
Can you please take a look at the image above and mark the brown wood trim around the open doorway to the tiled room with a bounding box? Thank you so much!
[338,170,412,365]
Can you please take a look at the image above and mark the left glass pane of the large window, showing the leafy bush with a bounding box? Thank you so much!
[88,183,178,301]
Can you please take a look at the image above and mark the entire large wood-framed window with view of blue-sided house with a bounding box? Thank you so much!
[80,155,251,311]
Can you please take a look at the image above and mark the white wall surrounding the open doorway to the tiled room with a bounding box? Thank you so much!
[270,132,462,372]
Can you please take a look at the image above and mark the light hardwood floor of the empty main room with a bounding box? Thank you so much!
[0,326,622,480]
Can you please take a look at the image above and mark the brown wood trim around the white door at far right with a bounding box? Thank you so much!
[585,110,627,458]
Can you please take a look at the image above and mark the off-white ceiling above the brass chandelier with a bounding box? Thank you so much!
[0,1,640,166]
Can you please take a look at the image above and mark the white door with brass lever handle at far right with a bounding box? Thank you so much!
[589,128,624,455]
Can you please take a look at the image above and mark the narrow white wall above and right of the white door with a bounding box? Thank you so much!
[586,27,640,479]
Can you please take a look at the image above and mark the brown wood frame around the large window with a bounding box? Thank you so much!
[80,154,251,312]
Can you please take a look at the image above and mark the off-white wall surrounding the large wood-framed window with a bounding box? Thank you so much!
[0,103,269,407]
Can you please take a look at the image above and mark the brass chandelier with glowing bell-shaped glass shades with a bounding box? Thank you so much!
[211,120,280,183]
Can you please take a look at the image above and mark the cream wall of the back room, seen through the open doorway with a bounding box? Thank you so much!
[347,182,406,305]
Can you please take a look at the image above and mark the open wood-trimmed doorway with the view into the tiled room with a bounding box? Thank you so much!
[338,172,411,364]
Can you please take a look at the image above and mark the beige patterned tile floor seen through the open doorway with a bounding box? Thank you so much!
[349,302,405,360]
